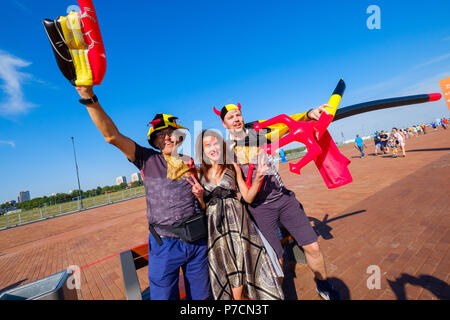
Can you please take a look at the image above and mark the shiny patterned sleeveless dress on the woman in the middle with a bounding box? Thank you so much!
[200,169,284,300]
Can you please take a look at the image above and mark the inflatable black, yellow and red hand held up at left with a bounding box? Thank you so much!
[43,0,106,86]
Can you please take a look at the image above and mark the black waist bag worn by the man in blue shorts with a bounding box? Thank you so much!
[149,213,208,245]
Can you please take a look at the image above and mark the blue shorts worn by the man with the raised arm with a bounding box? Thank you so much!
[148,234,210,300]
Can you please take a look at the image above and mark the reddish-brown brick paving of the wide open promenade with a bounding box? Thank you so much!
[0,128,450,300]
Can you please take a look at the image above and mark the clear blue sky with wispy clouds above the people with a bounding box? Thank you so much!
[0,0,450,203]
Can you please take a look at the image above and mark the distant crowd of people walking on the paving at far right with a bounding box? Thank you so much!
[354,118,448,158]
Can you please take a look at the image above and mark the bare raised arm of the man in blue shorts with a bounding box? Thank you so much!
[76,86,136,162]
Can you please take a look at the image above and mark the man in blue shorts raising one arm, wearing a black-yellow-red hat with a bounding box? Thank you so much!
[76,86,210,300]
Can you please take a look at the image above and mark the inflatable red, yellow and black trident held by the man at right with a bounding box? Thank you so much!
[246,79,442,189]
